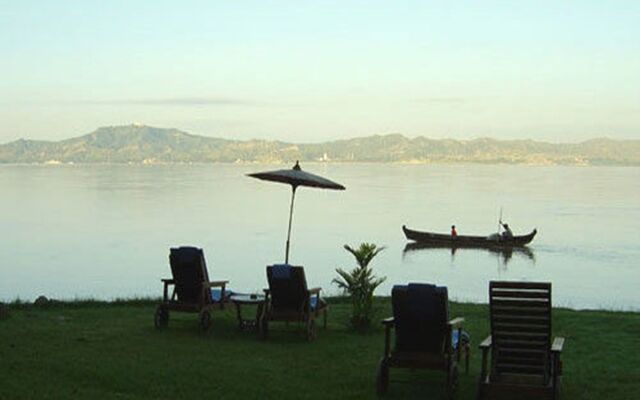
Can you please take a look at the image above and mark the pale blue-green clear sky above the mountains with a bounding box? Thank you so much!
[0,0,640,143]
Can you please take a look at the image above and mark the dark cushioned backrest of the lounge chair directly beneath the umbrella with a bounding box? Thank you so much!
[267,264,309,312]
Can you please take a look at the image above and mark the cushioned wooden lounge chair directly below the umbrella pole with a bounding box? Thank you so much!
[259,264,328,340]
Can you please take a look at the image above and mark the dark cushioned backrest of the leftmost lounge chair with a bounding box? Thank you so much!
[169,247,211,304]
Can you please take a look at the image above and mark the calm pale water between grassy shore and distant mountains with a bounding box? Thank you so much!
[0,164,640,310]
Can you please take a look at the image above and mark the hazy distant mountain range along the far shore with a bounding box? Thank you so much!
[0,124,640,165]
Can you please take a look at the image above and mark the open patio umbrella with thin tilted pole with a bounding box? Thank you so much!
[247,161,345,264]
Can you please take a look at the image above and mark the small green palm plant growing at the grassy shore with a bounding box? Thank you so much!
[333,243,386,329]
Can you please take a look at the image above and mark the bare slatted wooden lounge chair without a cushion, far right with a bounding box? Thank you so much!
[478,282,564,399]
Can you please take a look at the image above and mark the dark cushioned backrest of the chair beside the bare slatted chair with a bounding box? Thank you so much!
[391,284,451,354]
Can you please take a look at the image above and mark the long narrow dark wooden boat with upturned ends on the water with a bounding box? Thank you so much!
[402,225,538,247]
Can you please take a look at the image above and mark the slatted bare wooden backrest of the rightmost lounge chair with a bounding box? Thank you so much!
[489,282,551,383]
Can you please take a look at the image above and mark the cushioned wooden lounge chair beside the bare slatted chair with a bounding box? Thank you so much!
[376,283,469,396]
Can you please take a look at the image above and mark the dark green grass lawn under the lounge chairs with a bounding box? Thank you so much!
[0,298,640,399]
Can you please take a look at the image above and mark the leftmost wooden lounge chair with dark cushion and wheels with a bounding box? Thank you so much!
[154,247,229,331]
